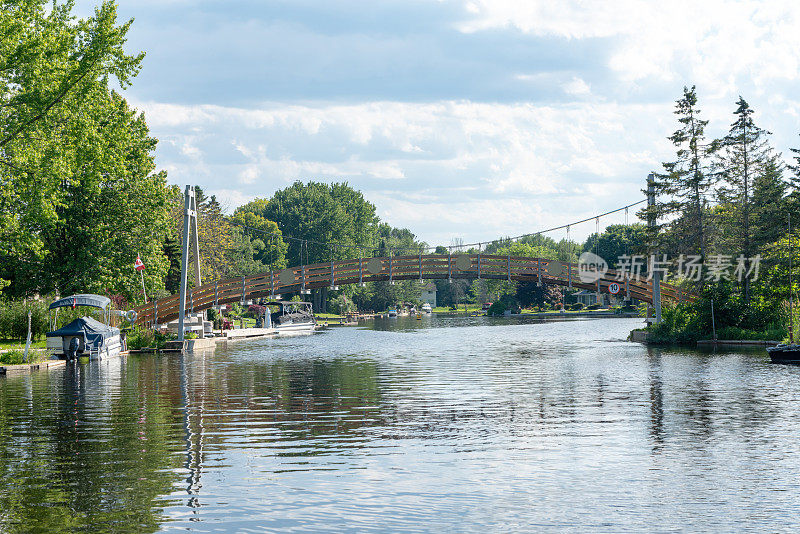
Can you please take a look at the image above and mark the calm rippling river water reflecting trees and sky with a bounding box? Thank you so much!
[0,317,800,532]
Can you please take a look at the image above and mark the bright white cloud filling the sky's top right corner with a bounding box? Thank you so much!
[459,0,800,96]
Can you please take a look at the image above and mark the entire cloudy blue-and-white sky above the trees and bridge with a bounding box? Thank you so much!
[78,0,800,244]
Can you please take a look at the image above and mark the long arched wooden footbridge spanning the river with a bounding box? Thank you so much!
[134,254,696,325]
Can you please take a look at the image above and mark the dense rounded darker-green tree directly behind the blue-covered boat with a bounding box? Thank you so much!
[9,87,170,300]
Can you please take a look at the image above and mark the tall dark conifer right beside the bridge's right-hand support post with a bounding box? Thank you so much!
[639,86,715,264]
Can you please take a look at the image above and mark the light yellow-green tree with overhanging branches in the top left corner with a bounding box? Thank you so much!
[0,0,144,276]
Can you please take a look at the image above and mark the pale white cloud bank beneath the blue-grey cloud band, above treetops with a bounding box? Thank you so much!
[133,101,670,243]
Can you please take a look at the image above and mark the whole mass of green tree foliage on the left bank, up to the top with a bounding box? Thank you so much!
[0,4,169,304]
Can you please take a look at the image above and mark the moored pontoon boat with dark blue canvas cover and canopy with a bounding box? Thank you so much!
[46,294,125,360]
